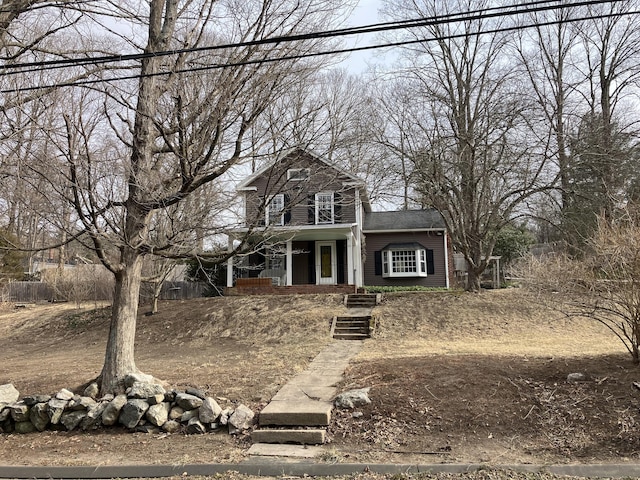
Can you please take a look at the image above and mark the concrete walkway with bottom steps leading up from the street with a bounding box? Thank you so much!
[249,340,362,448]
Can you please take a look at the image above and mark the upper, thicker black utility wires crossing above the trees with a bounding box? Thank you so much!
[0,0,625,73]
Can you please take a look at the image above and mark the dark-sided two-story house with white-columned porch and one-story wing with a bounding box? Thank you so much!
[227,149,453,294]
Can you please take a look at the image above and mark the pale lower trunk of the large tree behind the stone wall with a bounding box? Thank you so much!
[100,251,142,395]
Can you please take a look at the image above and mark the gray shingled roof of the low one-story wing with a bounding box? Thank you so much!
[362,209,446,232]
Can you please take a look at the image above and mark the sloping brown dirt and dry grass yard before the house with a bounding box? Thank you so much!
[0,289,640,465]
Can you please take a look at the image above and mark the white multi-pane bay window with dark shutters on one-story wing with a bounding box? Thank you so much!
[375,243,434,278]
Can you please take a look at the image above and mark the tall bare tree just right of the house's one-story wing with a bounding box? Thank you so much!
[386,0,548,291]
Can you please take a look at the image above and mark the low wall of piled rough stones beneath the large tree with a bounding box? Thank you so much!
[0,375,254,434]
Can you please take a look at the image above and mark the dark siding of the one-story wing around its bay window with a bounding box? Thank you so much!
[364,232,447,287]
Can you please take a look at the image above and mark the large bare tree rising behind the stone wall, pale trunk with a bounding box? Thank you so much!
[20,0,352,392]
